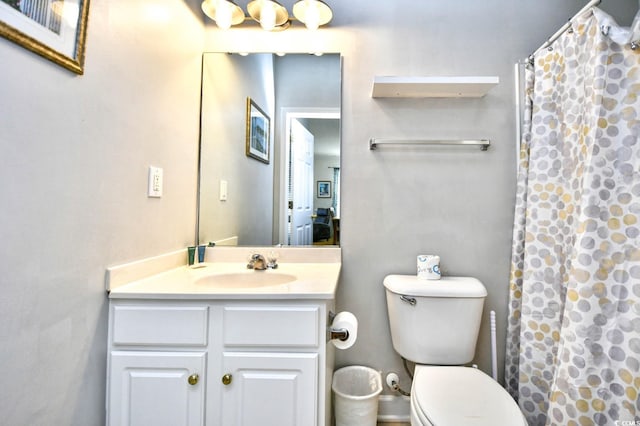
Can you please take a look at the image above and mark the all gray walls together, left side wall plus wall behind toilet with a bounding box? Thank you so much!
[0,0,637,426]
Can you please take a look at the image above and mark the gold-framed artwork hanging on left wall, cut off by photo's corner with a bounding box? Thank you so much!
[0,0,89,74]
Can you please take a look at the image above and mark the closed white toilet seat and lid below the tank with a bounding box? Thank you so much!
[411,365,527,426]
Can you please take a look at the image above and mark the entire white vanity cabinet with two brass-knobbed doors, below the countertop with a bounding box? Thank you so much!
[107,298,333,426]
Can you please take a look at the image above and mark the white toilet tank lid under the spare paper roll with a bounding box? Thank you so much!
[383,275,487,297]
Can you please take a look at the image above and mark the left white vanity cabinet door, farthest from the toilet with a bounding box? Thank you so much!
[108,351,205,426]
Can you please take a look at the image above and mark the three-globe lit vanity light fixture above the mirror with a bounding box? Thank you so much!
[202,0,333,31]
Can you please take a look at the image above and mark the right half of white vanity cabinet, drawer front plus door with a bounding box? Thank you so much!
[221,303,326,426]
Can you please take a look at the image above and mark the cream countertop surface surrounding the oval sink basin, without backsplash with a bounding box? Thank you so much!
[109,262,341,299]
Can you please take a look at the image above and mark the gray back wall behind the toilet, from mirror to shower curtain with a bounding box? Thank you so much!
[336,0,637,387]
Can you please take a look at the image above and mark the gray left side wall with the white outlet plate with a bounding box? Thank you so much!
[0,0,204,426]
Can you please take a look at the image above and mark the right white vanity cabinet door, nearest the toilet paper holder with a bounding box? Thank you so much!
[220,352,318,426]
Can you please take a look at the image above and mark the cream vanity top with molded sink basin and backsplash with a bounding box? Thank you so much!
[107,247,342,300]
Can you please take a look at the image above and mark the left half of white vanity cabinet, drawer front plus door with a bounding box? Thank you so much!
[107,301,209,426]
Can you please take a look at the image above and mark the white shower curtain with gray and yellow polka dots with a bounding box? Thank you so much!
[505,8,640,426]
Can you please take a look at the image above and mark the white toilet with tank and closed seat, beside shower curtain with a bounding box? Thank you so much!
[384,275,527,426]
